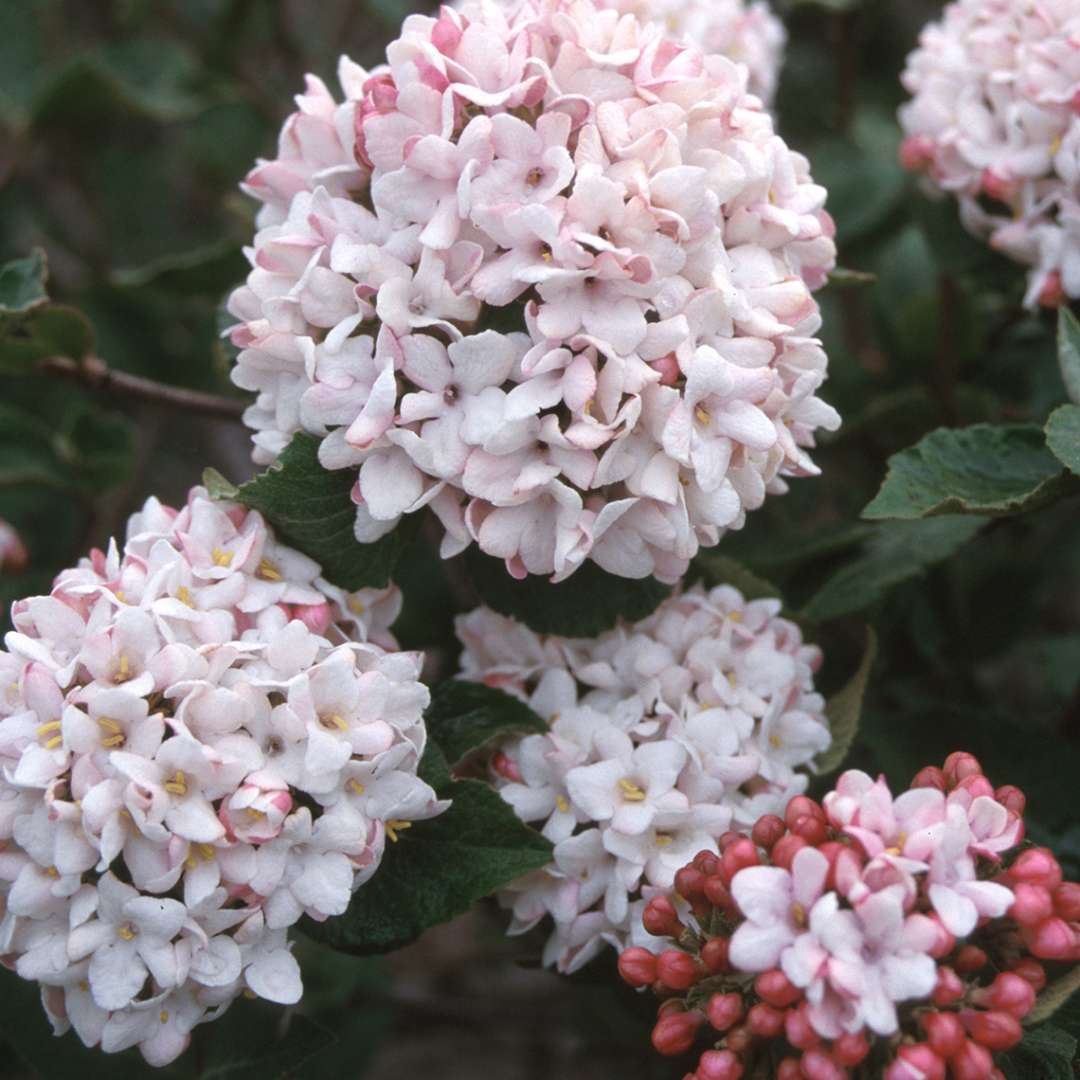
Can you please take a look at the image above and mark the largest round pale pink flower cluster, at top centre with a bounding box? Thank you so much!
[229,0,839,581]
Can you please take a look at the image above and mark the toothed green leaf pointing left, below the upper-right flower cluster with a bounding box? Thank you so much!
[863,423,1067,521]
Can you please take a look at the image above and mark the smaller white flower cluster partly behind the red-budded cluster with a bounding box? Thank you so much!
[458,586,829,971]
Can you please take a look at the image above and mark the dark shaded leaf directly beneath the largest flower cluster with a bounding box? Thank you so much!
[465,546,671,637]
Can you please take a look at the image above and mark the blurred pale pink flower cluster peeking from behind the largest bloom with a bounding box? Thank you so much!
[602,0,787,105]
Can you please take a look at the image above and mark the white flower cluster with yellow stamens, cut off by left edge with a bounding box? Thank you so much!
[0,488,443,1065]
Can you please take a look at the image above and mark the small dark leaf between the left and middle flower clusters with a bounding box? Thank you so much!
[424,679,548,765]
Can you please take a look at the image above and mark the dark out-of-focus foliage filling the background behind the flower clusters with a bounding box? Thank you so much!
[0,0,1080,1080]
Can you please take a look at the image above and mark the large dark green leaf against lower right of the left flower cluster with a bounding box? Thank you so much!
[306,780,552,954]
